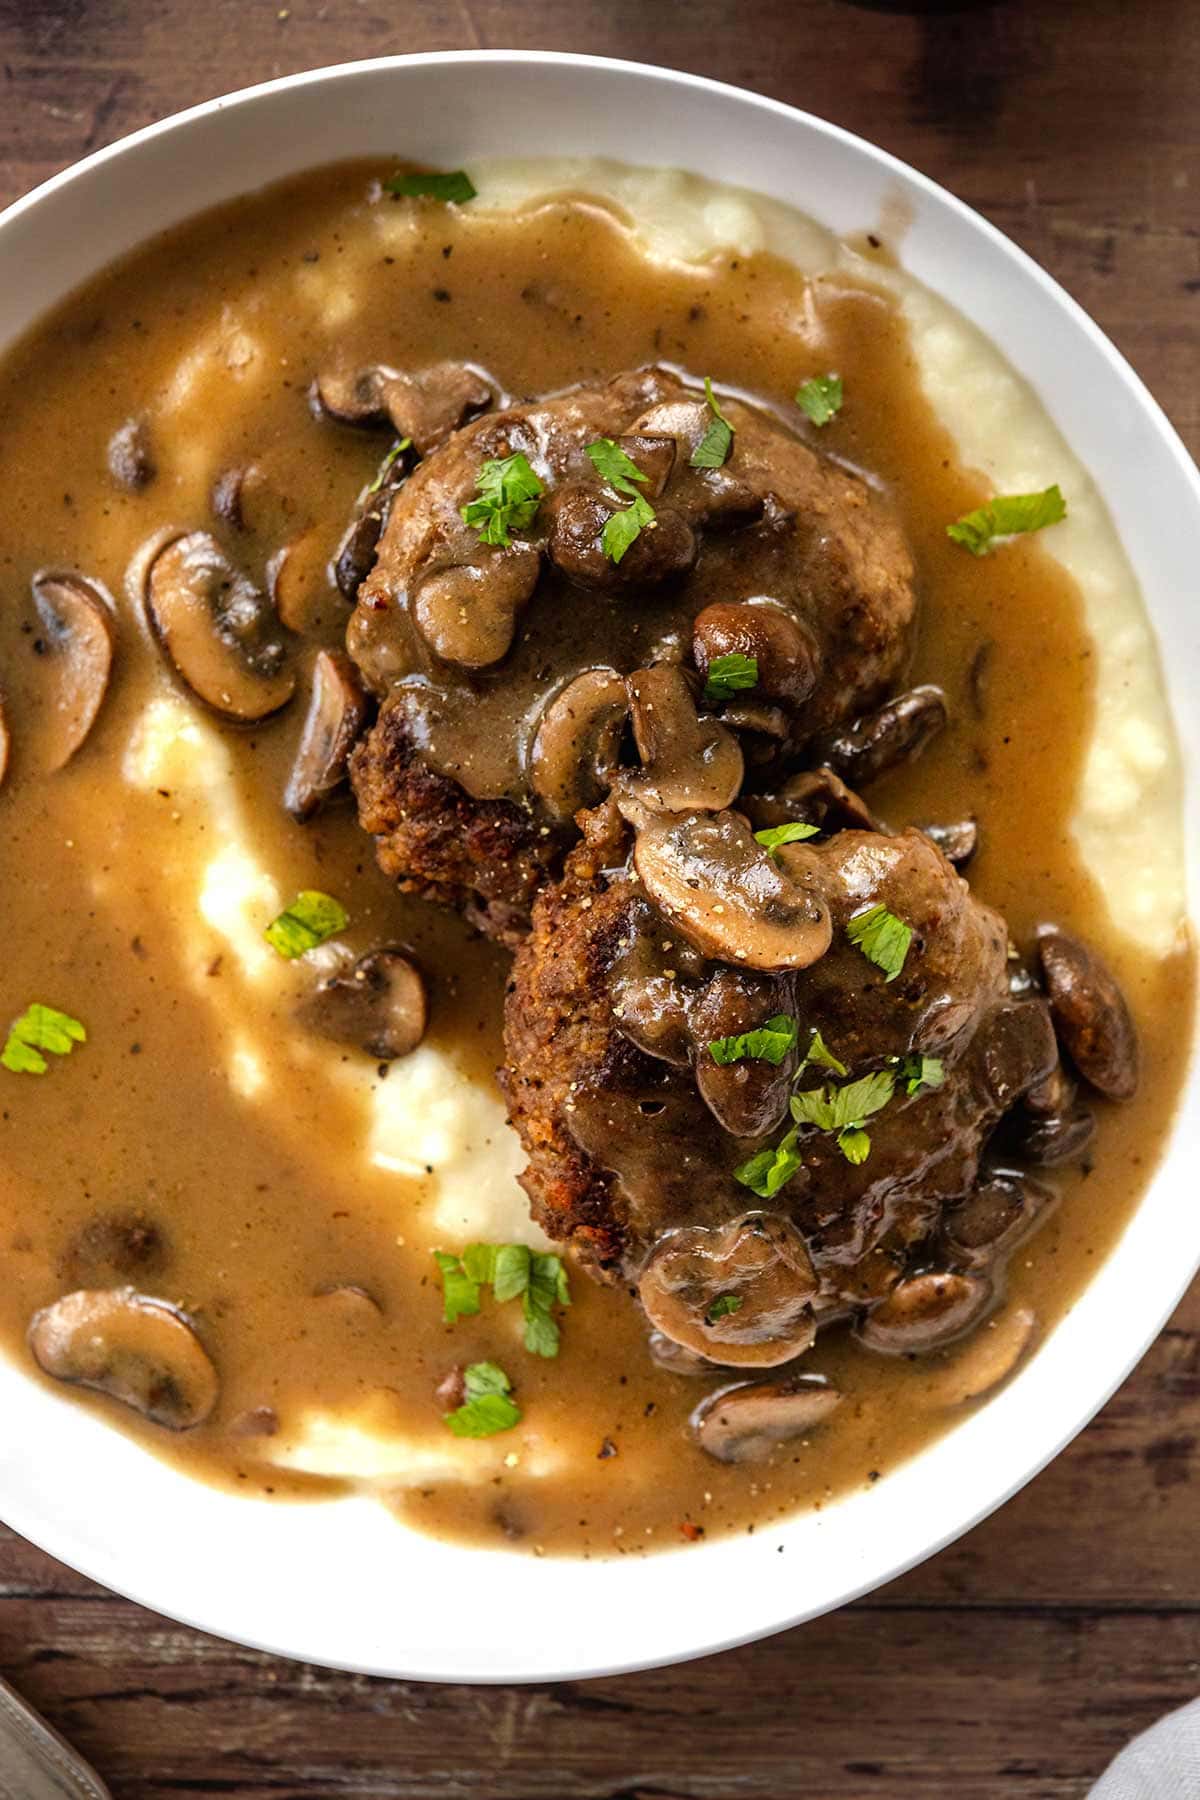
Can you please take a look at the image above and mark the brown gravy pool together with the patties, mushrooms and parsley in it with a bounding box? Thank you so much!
[0,166,1191,1555]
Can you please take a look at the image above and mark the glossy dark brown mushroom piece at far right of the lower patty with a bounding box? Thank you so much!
[1038,925,1141,1100]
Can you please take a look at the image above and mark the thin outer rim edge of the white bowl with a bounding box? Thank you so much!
[0,49,1200,1685]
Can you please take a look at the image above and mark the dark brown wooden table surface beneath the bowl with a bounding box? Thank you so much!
[0,0,1200,1800]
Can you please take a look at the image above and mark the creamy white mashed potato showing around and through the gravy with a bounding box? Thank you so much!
[116,158,1186,1487]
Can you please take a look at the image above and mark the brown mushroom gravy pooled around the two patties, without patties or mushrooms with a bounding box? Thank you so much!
[0,166,1193,1553]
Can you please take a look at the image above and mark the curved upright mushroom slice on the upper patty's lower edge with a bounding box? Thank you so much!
[529,668,630,819]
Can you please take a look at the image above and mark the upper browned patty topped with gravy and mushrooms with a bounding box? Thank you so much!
[347,369,916,938]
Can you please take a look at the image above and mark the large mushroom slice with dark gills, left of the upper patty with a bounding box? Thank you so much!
[144,531,295,724]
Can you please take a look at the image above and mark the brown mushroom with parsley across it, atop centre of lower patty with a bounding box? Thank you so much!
[689,968,795,1138]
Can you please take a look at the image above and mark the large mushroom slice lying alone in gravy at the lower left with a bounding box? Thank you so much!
[29,1287,218,1431]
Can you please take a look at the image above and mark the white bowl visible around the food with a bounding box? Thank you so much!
[0,50,1200,1681]
